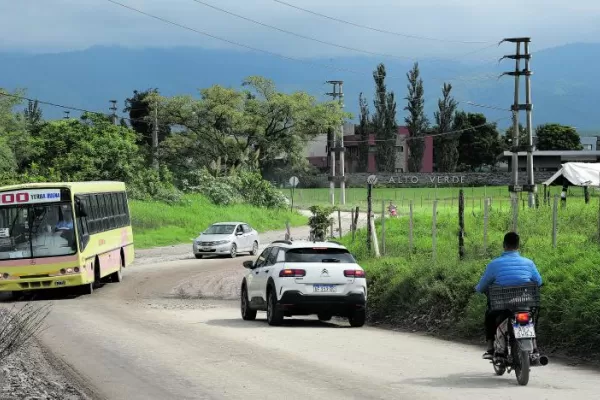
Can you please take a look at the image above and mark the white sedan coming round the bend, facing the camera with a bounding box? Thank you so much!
[192,222,260,258]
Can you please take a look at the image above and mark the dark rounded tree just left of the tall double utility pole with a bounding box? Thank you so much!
[452,111,502,171]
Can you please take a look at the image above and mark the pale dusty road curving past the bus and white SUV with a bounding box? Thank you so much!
[14,220,599,400]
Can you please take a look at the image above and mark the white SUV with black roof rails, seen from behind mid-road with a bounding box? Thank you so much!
[241,240,367,327]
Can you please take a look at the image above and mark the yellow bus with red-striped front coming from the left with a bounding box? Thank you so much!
[0,181,134,297]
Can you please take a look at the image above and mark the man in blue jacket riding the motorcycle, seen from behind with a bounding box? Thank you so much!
[475,232,542,359]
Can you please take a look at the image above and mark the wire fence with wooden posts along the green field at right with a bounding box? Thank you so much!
[334,193,600,261]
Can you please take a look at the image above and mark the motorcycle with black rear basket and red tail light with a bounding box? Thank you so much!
[488,284,549,386]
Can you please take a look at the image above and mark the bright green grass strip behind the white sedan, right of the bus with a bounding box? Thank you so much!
[129,195,308,249]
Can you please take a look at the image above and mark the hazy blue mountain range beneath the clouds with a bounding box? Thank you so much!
[0,43,600,134]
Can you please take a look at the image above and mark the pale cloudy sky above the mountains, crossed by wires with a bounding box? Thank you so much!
[0,0,600,60]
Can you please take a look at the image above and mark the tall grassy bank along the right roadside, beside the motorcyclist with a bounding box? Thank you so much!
[343,200,600,356]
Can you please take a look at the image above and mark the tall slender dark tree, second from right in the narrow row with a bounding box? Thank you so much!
[404,63,429,172]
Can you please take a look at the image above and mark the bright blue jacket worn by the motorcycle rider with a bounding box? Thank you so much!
[475,251,542,293]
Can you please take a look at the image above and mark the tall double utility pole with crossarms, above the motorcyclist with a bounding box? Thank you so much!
[500,37,537,207]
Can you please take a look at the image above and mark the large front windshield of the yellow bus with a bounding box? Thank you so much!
[0,203,77,260]
